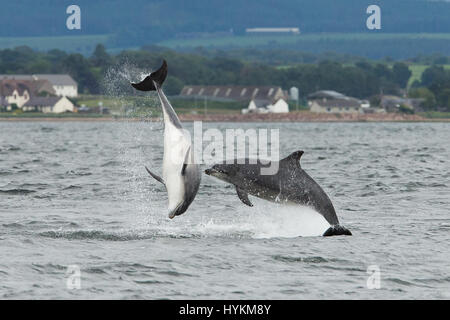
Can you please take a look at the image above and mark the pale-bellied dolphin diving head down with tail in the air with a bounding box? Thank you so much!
[131,60,201,219]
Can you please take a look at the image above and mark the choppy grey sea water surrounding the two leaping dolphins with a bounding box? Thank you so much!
[0,122,450,299]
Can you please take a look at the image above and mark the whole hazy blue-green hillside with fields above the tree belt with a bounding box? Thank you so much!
[0,0,450,58]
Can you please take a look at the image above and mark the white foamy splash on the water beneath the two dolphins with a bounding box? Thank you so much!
[39,207,330,241]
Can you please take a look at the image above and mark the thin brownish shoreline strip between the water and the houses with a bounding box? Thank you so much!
[0,112,450,122]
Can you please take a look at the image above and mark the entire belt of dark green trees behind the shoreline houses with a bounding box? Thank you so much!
[0,45,450,109]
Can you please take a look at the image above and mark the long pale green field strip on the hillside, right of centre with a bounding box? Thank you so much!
[158,32,450,59]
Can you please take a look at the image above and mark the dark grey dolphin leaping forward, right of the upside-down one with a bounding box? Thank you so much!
[205,151,351,236]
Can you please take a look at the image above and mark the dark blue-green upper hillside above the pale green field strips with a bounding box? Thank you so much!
[0,0,450,42]
